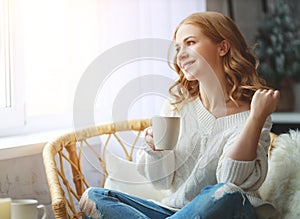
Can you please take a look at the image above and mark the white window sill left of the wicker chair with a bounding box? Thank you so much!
[0,113,73,160]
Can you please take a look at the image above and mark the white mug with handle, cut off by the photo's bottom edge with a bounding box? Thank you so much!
[11,199,48,219]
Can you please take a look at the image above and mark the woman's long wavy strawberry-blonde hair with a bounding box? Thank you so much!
[169,12,266,106]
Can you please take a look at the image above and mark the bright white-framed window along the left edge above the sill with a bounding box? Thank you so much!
[0,0,24,129]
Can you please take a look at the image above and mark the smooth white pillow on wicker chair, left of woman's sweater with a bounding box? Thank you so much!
[104,151,164,201]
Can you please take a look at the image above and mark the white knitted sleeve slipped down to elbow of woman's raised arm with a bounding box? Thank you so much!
[216,118,271,191]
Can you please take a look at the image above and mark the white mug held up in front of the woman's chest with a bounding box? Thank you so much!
[151,116,180,150]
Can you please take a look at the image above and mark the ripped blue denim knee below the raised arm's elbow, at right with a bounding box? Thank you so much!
[169,183,256,219]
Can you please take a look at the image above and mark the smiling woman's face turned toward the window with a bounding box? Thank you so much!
[175,24,219,81]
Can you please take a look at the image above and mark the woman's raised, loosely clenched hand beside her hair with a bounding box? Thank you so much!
[250,89,280,119]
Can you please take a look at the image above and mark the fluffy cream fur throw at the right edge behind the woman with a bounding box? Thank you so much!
[259,130,300,219]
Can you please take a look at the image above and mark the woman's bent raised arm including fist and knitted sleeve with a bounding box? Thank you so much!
[217,90,279,191]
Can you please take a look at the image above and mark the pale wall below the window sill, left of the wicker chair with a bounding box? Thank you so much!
[0,154,54,219]
